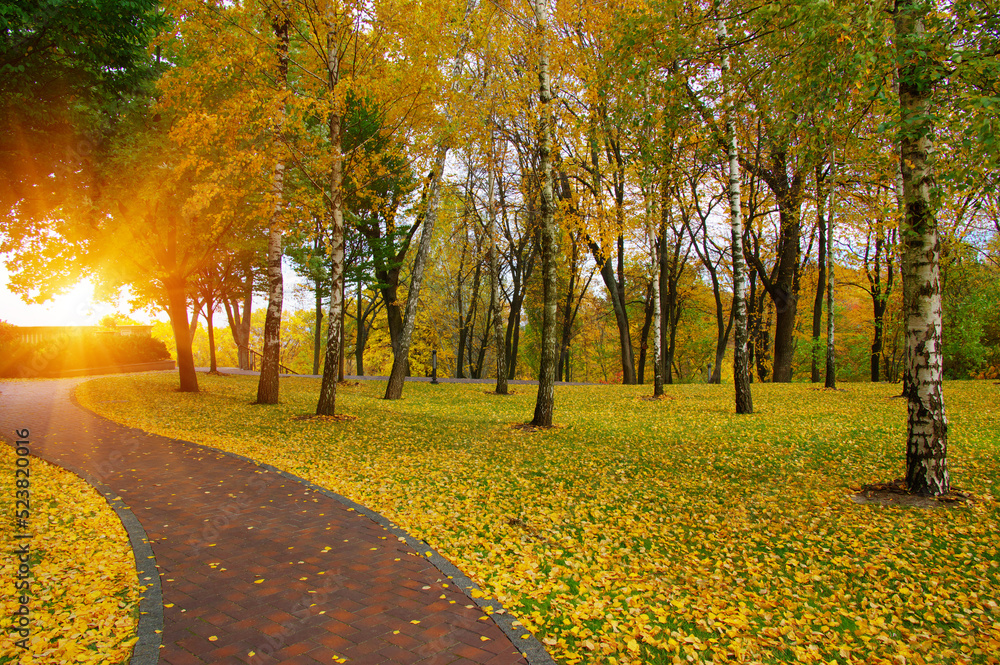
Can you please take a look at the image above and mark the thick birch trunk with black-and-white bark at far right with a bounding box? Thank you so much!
[894,0,951,496]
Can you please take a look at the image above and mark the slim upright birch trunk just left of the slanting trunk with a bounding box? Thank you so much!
[316,24,349,416]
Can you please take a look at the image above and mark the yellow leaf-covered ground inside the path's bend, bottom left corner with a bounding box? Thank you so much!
[0,443,139,665]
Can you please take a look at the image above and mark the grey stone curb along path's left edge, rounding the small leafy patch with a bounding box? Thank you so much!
[3,437,163,665]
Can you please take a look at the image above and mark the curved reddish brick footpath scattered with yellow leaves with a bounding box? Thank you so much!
[0,379,552,665]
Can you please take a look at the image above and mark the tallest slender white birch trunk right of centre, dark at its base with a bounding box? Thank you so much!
[719,21,753,413]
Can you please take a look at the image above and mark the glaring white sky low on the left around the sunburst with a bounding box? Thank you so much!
[0,257,310,326]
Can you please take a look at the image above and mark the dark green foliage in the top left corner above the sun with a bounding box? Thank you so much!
[0,0,162,217]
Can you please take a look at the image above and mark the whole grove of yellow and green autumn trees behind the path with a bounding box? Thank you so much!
[0,0,1000,494]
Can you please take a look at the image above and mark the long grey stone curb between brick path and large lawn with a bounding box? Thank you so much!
[72,391,556,665]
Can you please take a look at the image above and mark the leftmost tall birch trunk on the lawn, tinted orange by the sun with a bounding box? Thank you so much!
[257,13,290,404]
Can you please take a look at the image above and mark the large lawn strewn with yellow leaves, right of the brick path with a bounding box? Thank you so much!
[78,374,1000,664]
